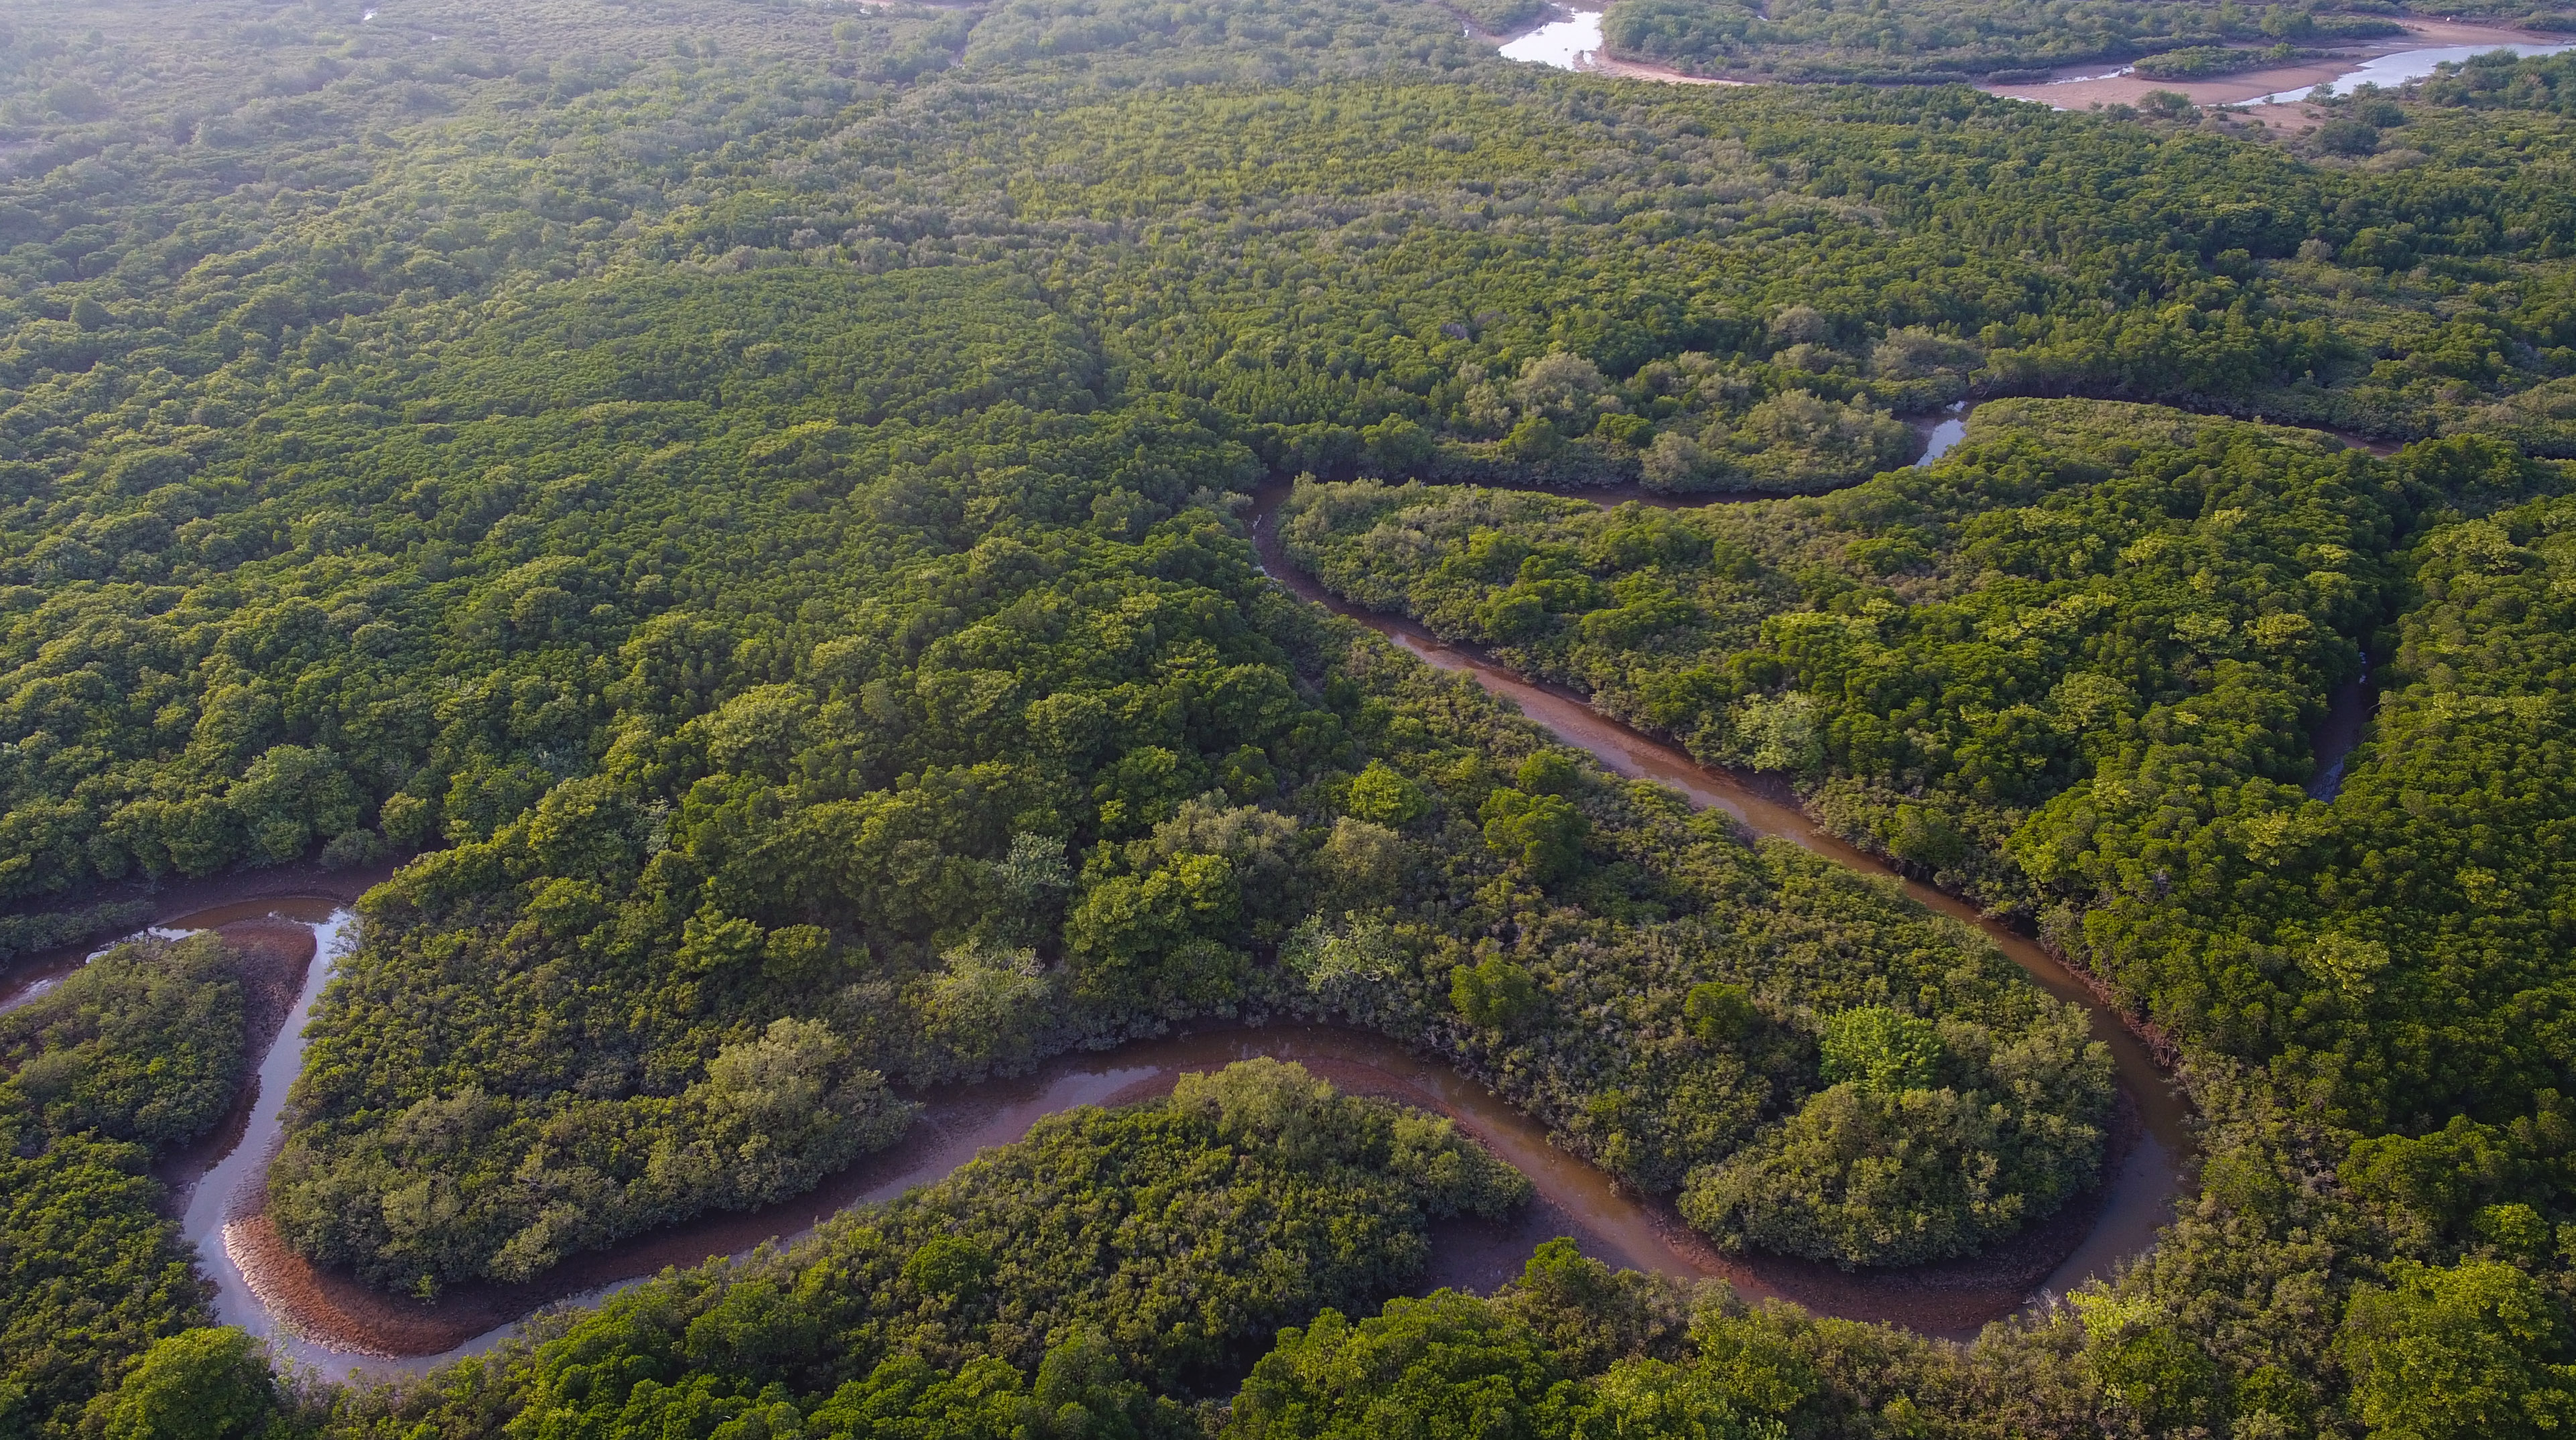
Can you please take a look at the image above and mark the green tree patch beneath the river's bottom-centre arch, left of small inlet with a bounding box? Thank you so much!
[322,1061,1530,1435]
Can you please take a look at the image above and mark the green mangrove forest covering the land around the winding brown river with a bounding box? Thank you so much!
[0,0,2576,1437]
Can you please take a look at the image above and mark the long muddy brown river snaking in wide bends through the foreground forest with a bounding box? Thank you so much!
[35,401,2410,1378]
